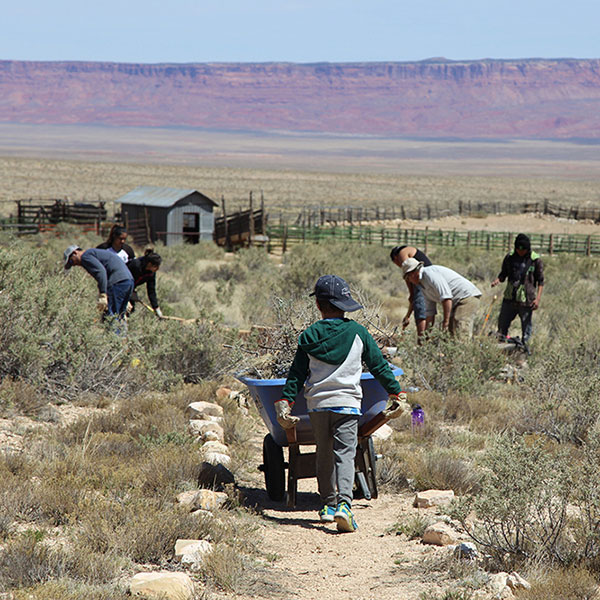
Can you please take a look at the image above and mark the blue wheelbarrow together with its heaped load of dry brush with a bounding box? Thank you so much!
[236,299,403,506]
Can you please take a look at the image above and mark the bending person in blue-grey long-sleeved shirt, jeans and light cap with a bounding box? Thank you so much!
[64,245,133,334]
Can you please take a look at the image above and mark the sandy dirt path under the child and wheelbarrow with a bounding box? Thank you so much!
[227,434,462,600]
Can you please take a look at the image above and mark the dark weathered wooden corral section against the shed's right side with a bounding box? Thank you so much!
[214,192,268,249]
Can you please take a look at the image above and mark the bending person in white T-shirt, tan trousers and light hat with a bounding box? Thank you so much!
[402,258,481,337]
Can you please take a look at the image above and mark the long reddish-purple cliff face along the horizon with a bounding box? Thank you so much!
[0,59,600,139]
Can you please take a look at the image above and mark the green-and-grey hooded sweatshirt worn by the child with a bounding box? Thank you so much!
[281,318,401,411]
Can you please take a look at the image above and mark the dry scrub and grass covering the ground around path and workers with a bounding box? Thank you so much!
[0,226,600,600]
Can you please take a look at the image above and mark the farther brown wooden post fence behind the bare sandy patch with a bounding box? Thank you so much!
[294,200,600,227]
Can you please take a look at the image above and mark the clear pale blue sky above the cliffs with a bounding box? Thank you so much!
[0,0,600,63]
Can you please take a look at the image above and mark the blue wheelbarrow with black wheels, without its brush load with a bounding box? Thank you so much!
[237,367,403,507]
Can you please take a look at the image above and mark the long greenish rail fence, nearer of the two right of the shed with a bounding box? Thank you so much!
[268,224,600,256]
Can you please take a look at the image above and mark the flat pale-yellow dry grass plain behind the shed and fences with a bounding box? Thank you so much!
[0,141,600,220]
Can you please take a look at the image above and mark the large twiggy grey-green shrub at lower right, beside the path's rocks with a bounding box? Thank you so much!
[451,434,574,566]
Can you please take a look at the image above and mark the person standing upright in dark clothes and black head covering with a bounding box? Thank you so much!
[492,233,544,349]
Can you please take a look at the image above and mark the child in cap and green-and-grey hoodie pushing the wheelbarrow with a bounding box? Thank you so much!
[275,275,410,532]
